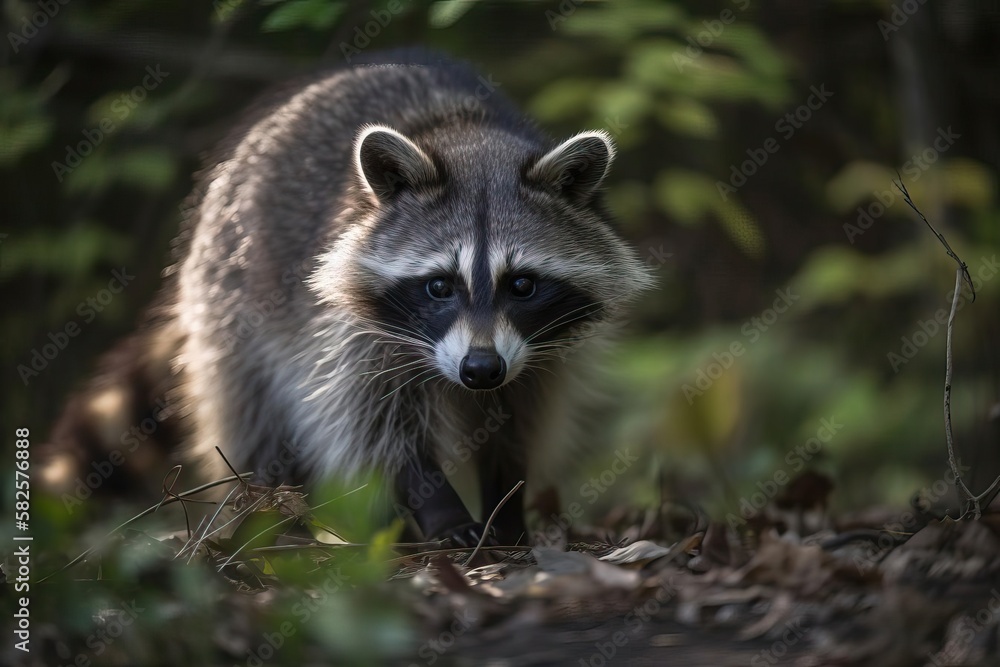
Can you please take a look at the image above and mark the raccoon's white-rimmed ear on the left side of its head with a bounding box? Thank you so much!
[354,125,438,200]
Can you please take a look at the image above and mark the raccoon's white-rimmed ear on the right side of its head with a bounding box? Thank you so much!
[527,130,615,204]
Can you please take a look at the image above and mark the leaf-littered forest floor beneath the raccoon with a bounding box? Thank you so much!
[7,473,1000,667]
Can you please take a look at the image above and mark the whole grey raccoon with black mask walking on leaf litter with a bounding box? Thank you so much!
[45,53,651,544]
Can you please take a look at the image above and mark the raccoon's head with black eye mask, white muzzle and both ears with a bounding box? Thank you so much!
[314,126,649,390]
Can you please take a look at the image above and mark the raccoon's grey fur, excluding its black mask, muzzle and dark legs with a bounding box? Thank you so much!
[167,56,650,516]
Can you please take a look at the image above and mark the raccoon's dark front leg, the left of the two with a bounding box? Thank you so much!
[396,452,492,546]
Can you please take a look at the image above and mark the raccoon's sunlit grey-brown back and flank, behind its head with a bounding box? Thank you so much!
[175,51,537,480]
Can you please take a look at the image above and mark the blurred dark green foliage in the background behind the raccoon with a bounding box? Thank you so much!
[0,0,1000,664]
